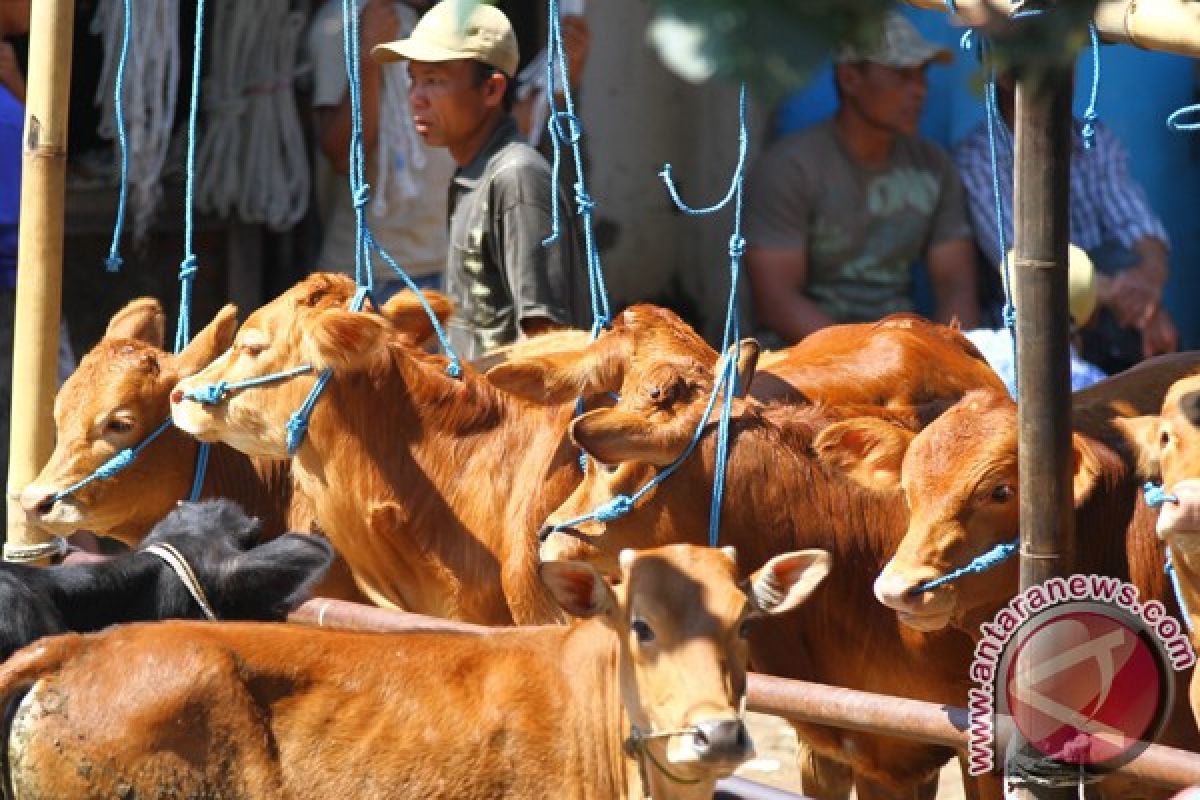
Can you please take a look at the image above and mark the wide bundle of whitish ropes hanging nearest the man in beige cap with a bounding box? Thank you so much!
[196,0,311,230]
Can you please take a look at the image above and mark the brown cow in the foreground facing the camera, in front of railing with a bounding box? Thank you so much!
[0,547,829,800]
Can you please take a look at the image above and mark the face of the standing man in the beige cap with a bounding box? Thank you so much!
[408,61,503,148]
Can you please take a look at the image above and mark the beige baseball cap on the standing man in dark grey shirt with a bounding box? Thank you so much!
[371,0,520,78]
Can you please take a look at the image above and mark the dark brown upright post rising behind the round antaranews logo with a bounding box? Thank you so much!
[1013,62,1078,799]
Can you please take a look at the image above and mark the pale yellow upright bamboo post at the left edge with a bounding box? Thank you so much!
[7,0,74,561]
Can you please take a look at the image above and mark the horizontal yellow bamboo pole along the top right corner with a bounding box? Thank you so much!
[907,0,1200,58]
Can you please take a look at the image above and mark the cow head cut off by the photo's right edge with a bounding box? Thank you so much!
[1116,375,1200,560]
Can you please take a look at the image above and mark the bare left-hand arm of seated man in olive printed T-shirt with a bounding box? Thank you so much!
[746,247,834,342]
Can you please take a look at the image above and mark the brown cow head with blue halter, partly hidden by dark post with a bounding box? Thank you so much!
[814,391,1099,631]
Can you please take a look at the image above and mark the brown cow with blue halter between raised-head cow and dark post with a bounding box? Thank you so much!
[502,340,1003,798]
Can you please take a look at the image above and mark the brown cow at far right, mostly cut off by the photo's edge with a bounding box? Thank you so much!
[1118,375,1200,723]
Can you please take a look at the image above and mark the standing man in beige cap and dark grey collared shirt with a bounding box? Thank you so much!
[372,0,588,359]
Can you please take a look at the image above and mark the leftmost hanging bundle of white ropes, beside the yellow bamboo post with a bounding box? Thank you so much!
[89,0,179,241]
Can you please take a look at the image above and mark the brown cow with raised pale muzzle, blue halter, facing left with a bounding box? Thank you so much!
[172,273,600,624]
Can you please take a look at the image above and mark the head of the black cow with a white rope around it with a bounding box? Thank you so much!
[141,499,334,620]
